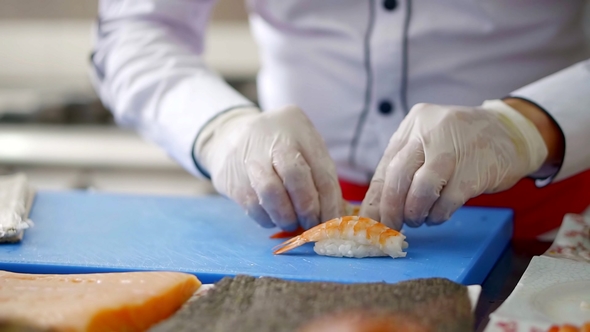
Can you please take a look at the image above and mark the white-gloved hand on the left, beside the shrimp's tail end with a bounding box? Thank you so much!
[195,106,343,231]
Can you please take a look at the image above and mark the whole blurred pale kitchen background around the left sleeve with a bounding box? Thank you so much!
[0,0,258,195]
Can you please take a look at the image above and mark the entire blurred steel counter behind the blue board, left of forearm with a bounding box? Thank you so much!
[0,125,215,195]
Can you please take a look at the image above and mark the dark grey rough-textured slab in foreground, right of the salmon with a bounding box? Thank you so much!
[150,275,474,332]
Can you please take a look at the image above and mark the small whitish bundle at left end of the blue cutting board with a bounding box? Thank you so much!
[0,173,34,243]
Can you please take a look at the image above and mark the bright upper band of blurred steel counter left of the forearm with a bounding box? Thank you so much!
[0,125,182,171]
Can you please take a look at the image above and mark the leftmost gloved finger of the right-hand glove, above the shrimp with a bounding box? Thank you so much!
[359,137,405,224]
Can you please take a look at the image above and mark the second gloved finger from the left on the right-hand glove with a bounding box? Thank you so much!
[379,140,424,229]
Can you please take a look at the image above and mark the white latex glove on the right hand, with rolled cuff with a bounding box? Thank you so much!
[360,100,548,230]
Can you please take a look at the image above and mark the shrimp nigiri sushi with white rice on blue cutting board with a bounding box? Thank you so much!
[274,216,408,258]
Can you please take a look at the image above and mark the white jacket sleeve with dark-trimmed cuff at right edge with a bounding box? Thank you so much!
[511,59,590,186]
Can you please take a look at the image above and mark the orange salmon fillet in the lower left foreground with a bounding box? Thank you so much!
[0,271,201,331]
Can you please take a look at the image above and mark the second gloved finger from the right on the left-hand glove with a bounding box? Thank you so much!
[273,149,320,229]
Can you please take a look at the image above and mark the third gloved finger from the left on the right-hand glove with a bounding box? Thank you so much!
[404,152,455,227]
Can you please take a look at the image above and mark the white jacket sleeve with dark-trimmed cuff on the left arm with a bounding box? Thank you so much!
[91,0,253,177]
